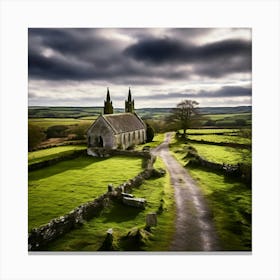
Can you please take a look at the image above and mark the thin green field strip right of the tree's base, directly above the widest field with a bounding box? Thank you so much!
[188,135,252,145]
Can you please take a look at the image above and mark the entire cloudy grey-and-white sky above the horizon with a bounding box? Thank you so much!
[28,28,252,108]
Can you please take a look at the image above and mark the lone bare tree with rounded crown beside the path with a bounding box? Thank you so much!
[168,100,199,136]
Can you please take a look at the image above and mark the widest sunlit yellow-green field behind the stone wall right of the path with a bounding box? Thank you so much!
[191,143,252,164]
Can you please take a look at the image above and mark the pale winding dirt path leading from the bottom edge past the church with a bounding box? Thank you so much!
[152,133,219,251]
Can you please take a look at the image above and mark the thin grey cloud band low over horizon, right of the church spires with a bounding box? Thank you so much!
[137,86,252,100]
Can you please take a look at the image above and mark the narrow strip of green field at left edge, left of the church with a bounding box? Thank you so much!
[28,145,86,164]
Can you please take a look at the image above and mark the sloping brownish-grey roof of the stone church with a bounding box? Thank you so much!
[102,113,146,134]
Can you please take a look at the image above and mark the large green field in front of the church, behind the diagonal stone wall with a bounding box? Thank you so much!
[28,156,142,230]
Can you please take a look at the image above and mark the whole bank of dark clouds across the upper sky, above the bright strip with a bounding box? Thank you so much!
[28,28,251,84]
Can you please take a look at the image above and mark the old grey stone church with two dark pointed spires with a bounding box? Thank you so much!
[87,88,146,150]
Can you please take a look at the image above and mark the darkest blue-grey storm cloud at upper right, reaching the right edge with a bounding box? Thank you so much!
[125,38,251,76]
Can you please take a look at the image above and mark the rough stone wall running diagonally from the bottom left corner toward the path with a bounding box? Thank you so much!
[28,152,161,251]
